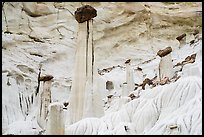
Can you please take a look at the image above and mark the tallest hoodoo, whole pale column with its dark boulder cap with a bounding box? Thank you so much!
[67,5,103,124]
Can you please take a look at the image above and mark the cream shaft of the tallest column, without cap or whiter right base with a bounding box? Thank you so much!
[69,20,93,122]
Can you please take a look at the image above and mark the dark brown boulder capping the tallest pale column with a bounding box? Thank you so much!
[74,5,97,23]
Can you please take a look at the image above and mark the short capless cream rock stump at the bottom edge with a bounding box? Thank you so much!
[46,102,65,135]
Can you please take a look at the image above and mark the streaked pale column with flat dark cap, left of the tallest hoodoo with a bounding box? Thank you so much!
[37,75,53,129]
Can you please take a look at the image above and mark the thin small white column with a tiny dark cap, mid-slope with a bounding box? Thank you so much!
[125,59,135,93]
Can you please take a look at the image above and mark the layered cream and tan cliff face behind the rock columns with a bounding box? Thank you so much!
[2,2,202,134]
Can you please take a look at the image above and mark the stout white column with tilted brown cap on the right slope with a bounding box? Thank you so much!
[157,47,174,81]
